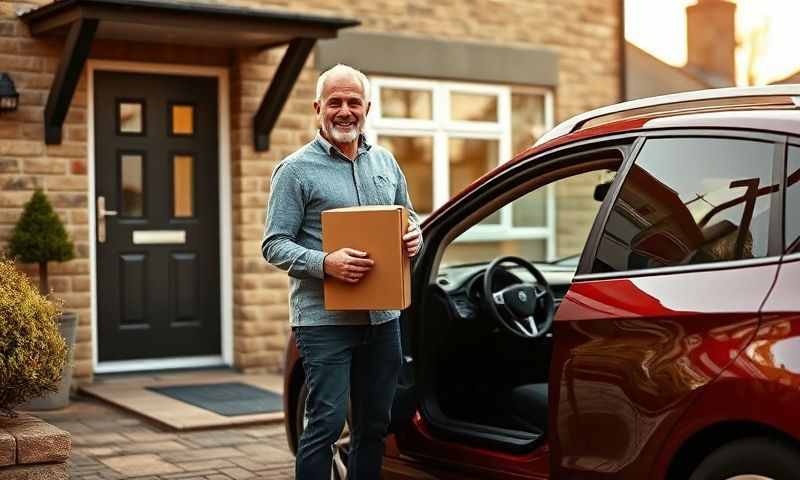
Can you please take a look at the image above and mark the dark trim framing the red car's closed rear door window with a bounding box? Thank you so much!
[574,128,786,282]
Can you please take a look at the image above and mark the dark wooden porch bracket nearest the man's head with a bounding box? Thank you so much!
[253,37,316,151]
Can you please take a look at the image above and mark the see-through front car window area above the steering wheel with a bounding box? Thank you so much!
[441,169,614,267]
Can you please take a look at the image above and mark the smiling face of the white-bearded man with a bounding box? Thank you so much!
[314,72,370,146]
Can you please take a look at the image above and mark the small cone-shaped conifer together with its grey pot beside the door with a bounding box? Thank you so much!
[8,190,78,409]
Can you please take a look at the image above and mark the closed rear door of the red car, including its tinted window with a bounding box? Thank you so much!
[550,132,783,480]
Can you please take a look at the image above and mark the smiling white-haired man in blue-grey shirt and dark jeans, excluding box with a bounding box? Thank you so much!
[261,65,422,480]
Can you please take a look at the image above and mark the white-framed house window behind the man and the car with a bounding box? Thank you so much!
[367,77,556,255]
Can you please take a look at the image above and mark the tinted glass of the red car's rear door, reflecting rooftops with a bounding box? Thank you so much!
[592,137,775,273]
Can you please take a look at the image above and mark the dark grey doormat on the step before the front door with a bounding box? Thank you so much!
[147,382,283,417]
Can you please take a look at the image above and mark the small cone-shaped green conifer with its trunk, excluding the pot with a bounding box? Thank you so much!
[8,190,74,295]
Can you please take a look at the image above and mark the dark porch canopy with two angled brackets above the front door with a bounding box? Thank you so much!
[19,0,360,150]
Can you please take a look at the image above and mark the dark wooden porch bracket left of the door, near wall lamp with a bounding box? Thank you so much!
[44,18,99,145]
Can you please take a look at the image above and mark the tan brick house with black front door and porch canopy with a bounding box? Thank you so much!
[0,0,624,381]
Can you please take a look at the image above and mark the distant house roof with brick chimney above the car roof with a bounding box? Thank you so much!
[625,0,736,100]
